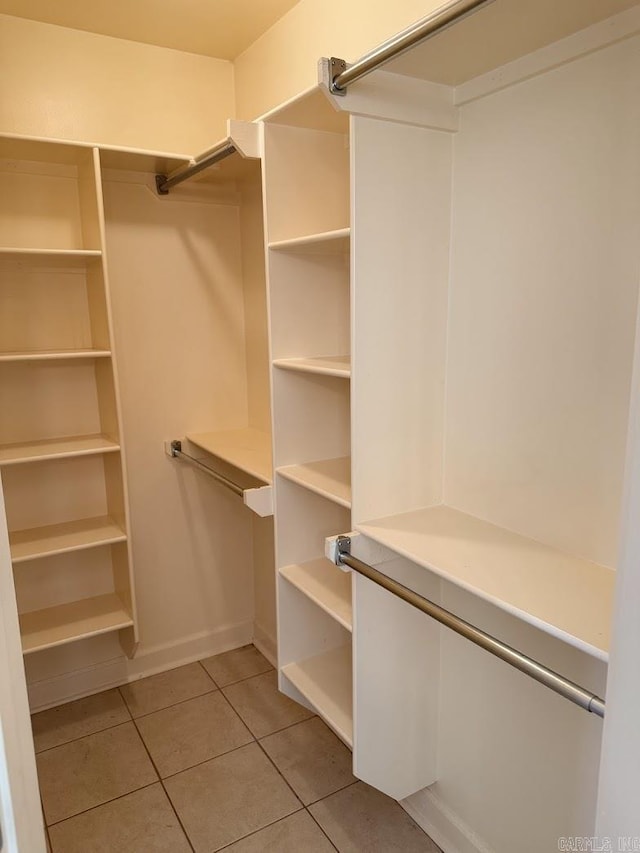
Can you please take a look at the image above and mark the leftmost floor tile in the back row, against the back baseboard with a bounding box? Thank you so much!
[31,690,131,752]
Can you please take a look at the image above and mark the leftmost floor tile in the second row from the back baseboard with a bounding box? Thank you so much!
[36,723,158,824]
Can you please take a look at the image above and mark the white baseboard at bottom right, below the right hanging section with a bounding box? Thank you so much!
[400,788,495,853]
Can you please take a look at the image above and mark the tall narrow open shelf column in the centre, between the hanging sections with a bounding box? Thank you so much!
[264,91,353,746]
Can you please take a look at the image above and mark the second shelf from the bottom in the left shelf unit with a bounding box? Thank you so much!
[9,516,127,564]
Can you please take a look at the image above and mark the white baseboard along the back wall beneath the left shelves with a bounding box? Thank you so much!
[27,622,252,713]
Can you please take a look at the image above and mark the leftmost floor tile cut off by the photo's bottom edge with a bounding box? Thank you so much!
[49,783,191,853]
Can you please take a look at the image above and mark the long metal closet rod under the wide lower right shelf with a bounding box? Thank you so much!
[336,536,605,717]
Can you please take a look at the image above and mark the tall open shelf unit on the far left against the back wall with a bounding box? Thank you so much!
[0,138,137,656]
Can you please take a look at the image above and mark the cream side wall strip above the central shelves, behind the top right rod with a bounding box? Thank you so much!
[235,0,442,119]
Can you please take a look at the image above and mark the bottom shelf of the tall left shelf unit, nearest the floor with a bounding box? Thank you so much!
[20,593,133,654]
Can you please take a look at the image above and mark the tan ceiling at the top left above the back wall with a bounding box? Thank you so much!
[0,0,298,59]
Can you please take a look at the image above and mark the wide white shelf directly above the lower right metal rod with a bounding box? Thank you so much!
[356,506,615,661]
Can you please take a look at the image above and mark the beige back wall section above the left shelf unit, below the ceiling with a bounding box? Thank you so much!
[0,15,234,154]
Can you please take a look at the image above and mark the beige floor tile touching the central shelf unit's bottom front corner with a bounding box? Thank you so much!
[260,717,356,805]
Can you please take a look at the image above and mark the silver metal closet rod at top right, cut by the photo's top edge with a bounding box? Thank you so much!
[331,0,493,95]
